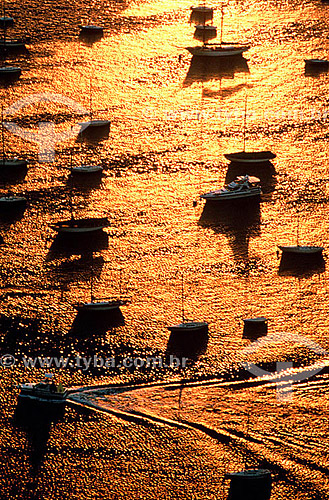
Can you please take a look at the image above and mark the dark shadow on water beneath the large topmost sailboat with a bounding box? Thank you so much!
[183,56,249,87]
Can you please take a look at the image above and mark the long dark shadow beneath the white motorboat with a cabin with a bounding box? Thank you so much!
[198,200,261,262]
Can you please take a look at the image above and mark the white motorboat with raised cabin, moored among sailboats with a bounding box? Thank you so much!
[200,175,262,202]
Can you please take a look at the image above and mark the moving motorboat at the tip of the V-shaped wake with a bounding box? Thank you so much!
[18,373,68,404]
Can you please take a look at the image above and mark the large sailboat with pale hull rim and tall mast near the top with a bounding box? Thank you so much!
[187,6,250,57]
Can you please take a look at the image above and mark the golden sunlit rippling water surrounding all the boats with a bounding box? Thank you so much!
[0,0,329,500]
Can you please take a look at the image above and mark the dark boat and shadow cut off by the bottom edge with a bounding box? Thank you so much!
[225,469,272,500]
